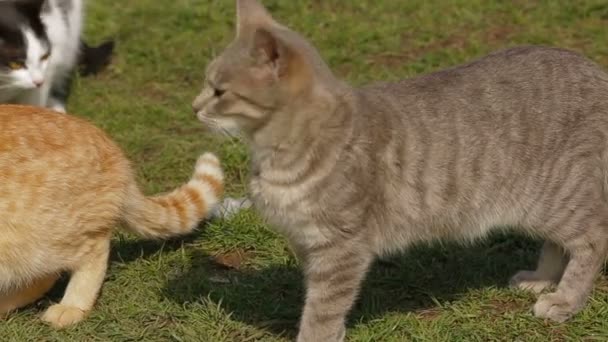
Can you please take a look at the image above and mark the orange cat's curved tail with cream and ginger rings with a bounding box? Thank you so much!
[123,153,224,239]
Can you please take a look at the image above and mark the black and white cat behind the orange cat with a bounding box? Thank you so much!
[0,0,112,112]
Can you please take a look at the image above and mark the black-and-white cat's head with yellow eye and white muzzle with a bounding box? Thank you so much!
[0,0,51,91]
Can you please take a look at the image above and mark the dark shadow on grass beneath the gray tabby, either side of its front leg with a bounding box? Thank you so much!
[164,234,540,338]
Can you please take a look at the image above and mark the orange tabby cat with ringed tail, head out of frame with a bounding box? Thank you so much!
[0,106,223,327]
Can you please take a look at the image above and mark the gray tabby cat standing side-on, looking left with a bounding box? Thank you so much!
[193,0,608,342]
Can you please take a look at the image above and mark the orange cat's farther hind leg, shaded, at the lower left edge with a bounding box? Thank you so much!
[0,274,59,318]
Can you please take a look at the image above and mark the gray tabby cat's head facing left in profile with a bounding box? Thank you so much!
[192,0,336,139]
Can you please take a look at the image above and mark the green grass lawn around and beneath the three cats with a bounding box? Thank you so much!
[0,0,608,341]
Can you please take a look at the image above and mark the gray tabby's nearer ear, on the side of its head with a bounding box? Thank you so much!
[251,28,311,91]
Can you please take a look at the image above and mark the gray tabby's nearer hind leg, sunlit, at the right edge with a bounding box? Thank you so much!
[534,221,608,322]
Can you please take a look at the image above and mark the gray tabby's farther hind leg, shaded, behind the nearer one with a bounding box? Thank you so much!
[510,241,568,293]
